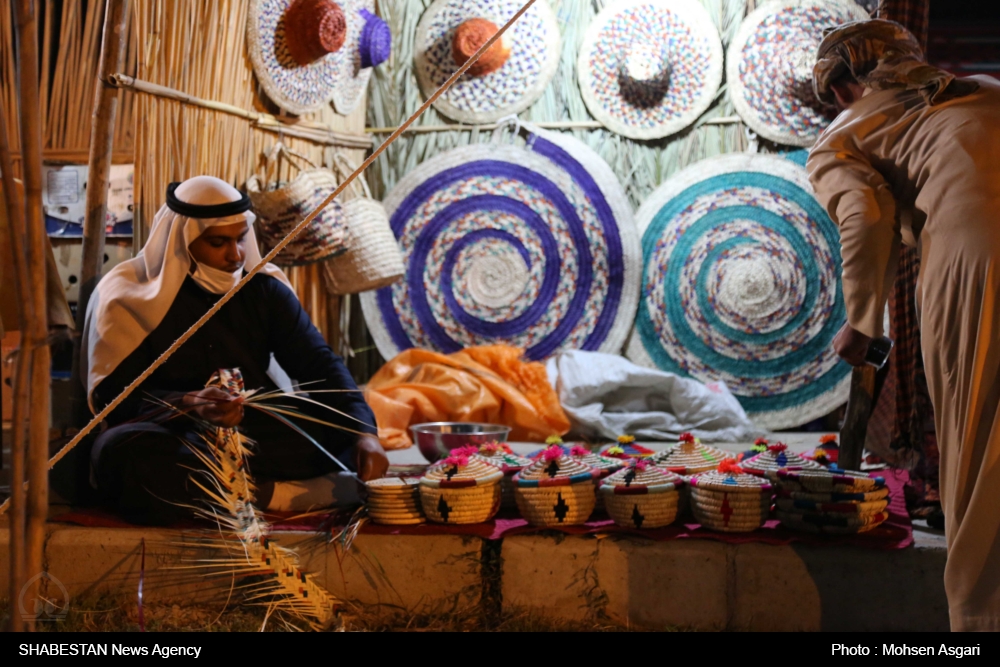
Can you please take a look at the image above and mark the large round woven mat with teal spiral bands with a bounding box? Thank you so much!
[627,154,850,429]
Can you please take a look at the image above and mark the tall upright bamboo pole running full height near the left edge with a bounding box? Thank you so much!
[15,0,50,629]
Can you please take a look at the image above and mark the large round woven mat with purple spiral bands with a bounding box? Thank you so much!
[361,131,641,359]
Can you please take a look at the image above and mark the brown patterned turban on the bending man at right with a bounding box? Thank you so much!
[813,19,979,106]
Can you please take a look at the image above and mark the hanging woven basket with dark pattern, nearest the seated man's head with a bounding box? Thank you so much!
[246,142,348,266]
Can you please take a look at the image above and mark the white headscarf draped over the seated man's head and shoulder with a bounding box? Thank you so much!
[82,176,294,412]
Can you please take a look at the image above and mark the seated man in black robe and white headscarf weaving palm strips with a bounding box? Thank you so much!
[84,176,388,523]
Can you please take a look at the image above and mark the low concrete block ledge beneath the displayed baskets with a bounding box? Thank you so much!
[0,524,948,631]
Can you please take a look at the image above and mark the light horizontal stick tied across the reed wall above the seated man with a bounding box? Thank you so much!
[111,73,372,148]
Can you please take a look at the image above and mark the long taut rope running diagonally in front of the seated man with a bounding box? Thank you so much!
[0,0,535,515]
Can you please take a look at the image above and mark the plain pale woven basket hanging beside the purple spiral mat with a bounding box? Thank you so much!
[323,153,405,294]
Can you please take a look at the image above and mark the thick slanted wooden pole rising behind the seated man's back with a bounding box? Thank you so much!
[70,0,128,423]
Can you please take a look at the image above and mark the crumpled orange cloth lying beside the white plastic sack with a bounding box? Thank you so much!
[365,345,569,449]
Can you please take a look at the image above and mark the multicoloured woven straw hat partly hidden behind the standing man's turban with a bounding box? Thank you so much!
[726,0,869,146]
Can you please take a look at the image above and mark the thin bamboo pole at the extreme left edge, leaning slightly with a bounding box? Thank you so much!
[0,75,31,632]
